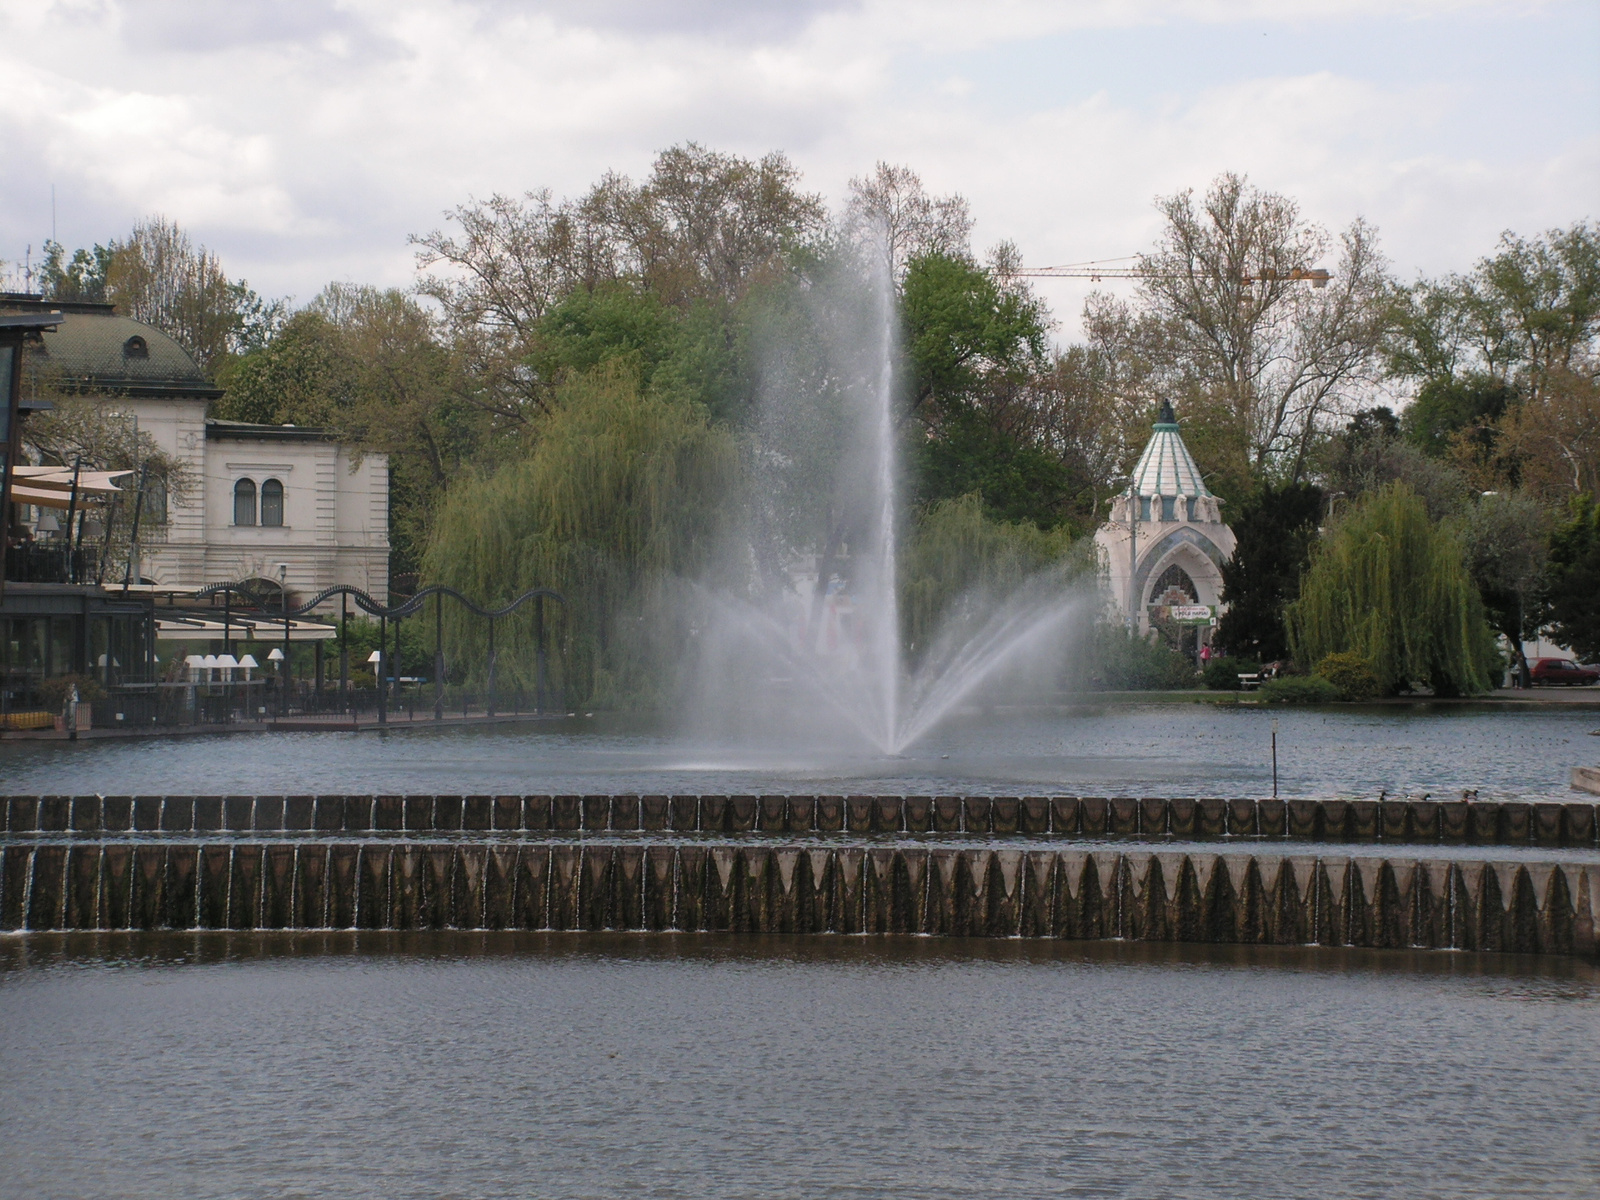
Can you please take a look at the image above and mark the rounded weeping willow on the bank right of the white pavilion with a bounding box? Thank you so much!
[1286,483,1499,694]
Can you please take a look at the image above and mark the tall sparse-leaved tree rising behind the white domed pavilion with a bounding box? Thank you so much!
[1139,173,1387,482]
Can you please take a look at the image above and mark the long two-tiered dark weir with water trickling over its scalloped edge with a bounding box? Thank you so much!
[0,795,1600,958]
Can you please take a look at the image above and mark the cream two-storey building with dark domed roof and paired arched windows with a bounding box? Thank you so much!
[11,296,389,600]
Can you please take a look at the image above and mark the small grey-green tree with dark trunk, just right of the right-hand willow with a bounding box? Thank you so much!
[1459,493,1549,683]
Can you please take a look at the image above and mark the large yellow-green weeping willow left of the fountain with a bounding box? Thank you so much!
[424,368,738,707]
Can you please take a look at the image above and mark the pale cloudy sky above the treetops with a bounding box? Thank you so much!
[0,0,1600,333]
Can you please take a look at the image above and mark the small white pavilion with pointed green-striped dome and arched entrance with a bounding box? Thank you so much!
[1094,403,1235,649]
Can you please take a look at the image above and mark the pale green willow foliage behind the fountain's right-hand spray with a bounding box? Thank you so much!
[899,494,1074,654]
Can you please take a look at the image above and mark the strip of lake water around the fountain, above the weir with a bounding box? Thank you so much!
[0,702,1600,798]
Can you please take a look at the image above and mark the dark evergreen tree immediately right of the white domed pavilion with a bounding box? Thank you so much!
[1216,483,1326,662]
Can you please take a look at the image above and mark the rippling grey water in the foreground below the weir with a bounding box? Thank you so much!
[0,934,1600,1200]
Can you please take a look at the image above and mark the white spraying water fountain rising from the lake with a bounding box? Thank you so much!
[690,244,1098,755]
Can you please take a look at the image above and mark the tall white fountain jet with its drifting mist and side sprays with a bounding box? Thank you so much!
[688,232,1088,758]
